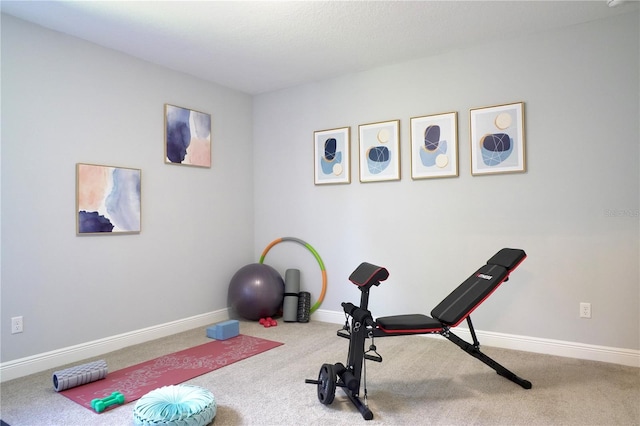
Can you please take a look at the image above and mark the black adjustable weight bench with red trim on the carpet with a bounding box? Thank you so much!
[306,248,531,420]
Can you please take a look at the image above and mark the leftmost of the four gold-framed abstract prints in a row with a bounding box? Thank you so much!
[313,127,351,185]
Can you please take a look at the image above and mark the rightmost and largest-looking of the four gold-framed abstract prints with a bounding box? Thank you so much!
[469,102,527,176]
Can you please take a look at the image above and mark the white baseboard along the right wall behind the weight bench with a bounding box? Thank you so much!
[311,310,640,367]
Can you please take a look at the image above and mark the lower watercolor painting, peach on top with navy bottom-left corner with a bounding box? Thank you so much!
[76,164,141,235]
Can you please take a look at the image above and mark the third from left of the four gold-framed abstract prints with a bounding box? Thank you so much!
[410,112,458,179]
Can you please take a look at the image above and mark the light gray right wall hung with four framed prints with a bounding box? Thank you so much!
[254,13,640,349]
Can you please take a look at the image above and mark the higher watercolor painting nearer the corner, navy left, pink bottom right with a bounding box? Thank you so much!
[164,104,211,167]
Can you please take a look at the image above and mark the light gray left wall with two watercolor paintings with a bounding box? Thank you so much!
[1,15,253,362]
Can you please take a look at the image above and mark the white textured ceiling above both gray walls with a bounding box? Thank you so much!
[0,0,638,94]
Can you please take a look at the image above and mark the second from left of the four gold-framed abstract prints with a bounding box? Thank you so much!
[358,120,400,182]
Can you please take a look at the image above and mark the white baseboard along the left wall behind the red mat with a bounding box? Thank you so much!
[0,309,229,382]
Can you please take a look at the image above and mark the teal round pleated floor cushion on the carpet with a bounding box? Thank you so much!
[133,385,217,426]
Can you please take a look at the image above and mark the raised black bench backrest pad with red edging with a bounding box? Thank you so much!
[431,248,527,327]
